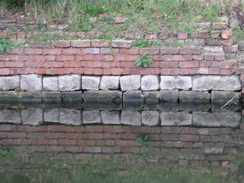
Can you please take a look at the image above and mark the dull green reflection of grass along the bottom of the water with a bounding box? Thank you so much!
[0,160,232,183]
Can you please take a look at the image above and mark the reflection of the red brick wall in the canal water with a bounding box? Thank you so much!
[0,124,244,172]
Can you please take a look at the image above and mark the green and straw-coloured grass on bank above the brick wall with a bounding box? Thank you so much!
[0,0,244,33]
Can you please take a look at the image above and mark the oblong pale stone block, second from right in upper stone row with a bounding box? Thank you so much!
[160,76,192,90]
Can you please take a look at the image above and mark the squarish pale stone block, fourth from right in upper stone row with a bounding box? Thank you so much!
[120,75,141,91]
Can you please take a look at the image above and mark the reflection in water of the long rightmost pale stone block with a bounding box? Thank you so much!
[193,111,241,127]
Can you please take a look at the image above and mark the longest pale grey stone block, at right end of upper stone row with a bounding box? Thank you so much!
[193,76,241,91]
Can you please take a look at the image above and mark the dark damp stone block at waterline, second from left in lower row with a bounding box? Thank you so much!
[19,92,42,103]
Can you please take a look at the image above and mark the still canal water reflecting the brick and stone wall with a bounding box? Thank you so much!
[0,101,244,183]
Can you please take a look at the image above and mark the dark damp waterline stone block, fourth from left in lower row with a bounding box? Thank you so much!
[61,91,83,104]
